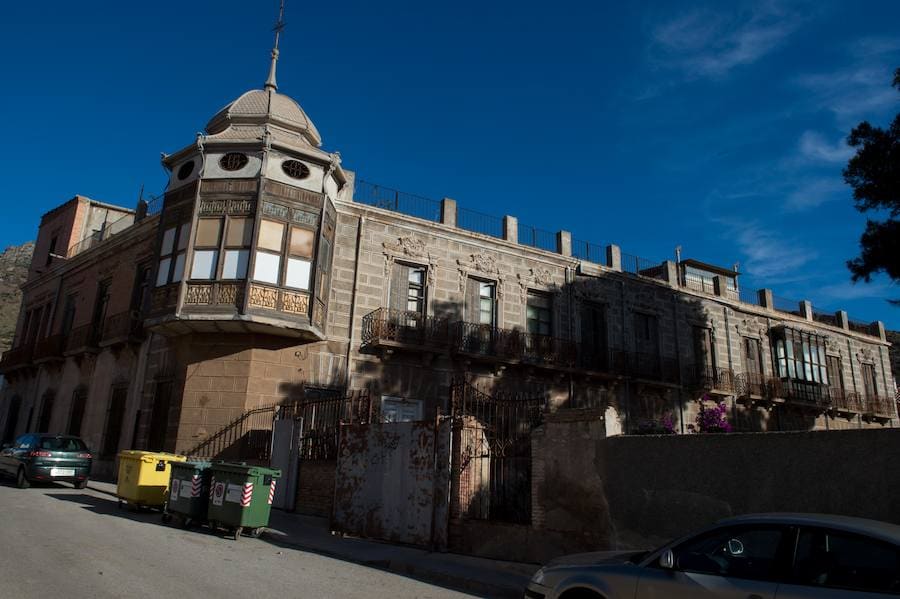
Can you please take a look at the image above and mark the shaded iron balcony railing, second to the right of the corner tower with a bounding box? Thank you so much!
[453,322,578,367]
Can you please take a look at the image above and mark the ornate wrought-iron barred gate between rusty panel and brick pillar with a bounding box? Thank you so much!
[451,381,546,524]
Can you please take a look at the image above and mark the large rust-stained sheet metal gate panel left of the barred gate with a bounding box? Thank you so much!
[332,422,449,547]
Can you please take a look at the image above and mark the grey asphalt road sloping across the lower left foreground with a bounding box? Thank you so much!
[0,479,478,599]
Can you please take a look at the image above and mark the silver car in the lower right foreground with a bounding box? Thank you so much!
[525,514,900,599]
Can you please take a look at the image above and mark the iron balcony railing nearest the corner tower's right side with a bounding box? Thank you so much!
[362,308,450,347]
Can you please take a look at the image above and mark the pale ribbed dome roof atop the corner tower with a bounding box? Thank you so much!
[206,88,322,148]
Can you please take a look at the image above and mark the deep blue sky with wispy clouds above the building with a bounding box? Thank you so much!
[0,0,900,329]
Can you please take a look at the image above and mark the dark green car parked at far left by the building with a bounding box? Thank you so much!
[0,433,93,489]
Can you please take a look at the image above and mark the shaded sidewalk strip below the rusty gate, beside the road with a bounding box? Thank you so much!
[88,481,538,597]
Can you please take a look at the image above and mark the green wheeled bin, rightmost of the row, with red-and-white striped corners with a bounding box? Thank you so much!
[206,462,281,540]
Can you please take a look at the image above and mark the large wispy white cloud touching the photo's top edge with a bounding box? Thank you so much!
[650,2,803,78]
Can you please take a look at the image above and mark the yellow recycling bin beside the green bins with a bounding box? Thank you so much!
[116,450,187,509]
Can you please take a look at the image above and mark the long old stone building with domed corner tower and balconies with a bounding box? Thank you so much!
[0,39,898,488]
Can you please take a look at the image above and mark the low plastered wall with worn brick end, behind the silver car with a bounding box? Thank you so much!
[528,424,900,560]
